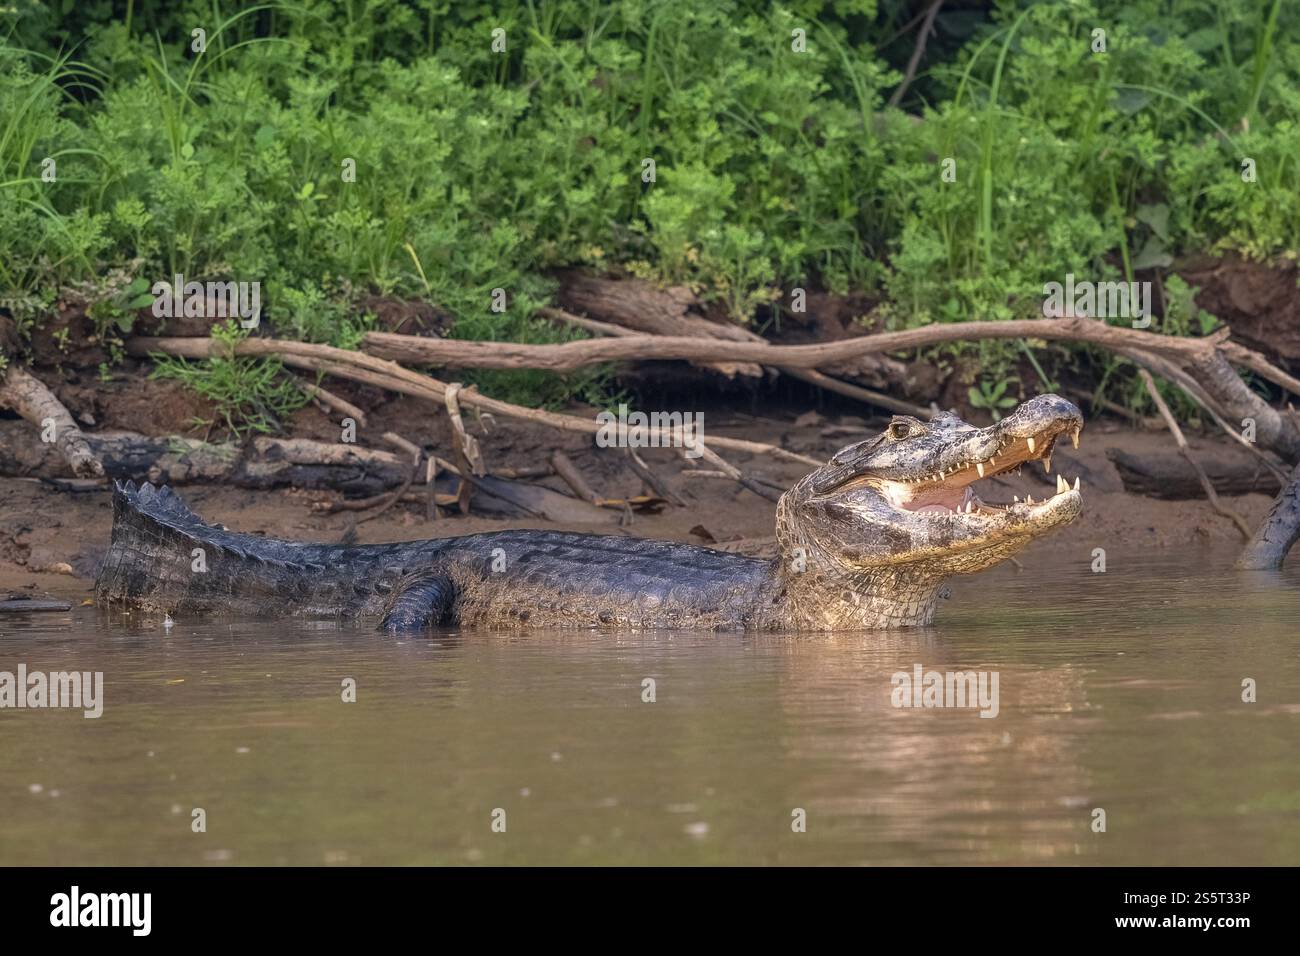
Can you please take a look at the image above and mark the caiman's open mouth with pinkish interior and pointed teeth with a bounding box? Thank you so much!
[875,421,1082,518]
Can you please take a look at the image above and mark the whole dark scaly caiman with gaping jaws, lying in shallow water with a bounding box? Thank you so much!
[96,395,1083,631]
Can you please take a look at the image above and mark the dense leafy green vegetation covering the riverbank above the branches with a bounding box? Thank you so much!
[0,0,1300,427]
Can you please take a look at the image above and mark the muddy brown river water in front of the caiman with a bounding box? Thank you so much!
[0,553,1300,865]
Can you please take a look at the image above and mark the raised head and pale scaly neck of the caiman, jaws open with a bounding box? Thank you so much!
[776,395,1083,628]
